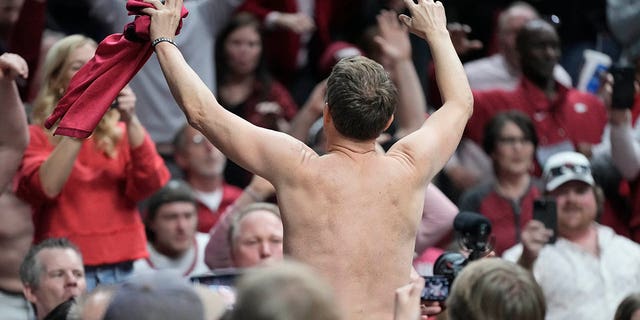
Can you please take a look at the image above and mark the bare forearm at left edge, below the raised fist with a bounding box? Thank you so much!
[0,79,29,190]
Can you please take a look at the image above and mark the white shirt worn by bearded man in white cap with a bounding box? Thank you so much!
[502,225,640,320]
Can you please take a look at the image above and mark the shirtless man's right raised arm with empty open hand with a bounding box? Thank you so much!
[388,0,473,183]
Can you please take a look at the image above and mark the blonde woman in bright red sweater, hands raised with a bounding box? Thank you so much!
[18,35,169,288]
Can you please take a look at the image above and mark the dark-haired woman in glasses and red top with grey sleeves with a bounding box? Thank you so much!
[458,110,542,255]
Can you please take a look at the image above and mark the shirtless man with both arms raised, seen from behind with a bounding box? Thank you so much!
[144,0,473,319]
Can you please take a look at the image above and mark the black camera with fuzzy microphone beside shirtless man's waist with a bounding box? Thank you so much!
[423,211,491,300]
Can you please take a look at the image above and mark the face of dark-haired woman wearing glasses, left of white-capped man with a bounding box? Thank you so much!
[491,122,534,175]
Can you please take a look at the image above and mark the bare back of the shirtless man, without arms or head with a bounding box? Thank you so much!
[278,151,425,319]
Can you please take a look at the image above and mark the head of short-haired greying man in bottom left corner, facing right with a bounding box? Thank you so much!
[20,238,86,320]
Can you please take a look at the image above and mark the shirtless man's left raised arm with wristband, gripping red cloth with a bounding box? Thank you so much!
[143,0,315,185]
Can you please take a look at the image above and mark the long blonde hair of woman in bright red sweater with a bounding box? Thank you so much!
[31,34,122,158]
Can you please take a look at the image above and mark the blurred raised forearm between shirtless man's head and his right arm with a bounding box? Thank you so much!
[393,60,426,138]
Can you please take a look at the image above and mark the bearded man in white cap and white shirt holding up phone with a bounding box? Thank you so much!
[503,152,640,319]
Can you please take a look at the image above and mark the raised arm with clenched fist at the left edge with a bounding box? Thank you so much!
[0,53,29,193]
